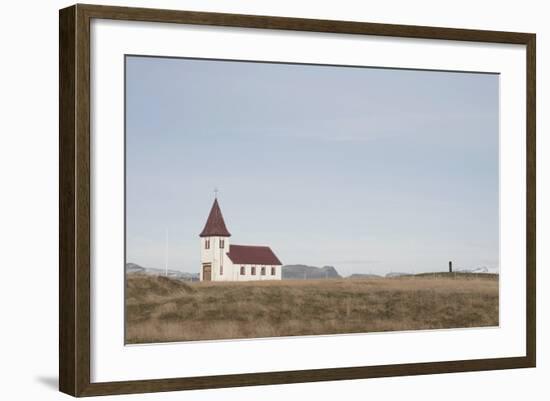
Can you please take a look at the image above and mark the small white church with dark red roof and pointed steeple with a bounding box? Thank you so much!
[199,198,282,281]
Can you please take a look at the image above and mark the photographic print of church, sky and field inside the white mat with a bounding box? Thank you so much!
[125,55,499,344]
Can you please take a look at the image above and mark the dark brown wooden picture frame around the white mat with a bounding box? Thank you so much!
[59,4,536,396]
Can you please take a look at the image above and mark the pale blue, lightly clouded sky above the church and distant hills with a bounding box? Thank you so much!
[126,56,499,275]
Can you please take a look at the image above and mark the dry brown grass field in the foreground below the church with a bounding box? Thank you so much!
[126,274,499,344]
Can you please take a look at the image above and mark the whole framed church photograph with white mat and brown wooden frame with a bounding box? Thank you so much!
[59,5,536,396]
